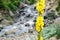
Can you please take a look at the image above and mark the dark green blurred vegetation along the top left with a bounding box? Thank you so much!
[0,0,35,11]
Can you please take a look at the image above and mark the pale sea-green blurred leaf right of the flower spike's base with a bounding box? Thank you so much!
[41,24,57,40]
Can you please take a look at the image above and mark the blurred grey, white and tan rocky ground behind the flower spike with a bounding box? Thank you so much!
[0,0,60,40]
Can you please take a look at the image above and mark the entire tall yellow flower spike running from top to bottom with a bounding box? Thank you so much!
[36,0,45,40]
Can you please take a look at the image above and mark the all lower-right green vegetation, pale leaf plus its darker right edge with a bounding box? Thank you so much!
[41,23,60,40]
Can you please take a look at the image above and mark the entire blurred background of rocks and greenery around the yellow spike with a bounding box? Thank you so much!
[0,0,60,40]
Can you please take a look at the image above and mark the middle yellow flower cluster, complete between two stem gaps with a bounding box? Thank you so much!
[36,16,44,32]
